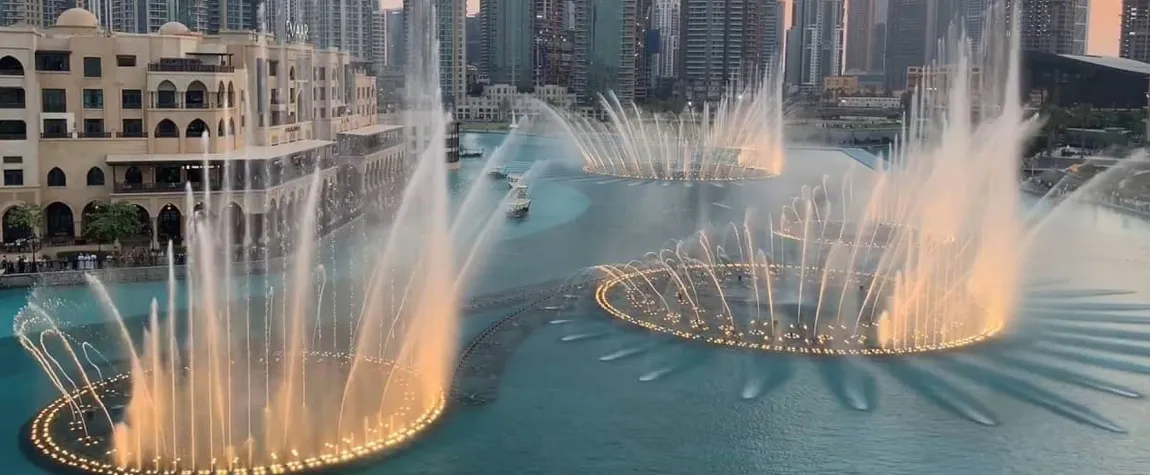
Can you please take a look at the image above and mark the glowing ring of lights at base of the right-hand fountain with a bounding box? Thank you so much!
[595,262,1003,357]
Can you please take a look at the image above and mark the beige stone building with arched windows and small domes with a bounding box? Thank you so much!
[0,8,404,246]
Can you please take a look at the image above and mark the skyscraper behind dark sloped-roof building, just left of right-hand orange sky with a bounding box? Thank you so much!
[1006,0,1090,54]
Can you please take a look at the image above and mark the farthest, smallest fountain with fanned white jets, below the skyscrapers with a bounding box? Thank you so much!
[549,69,783,181]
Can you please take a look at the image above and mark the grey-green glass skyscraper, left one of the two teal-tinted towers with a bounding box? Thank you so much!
[478,0,536,90]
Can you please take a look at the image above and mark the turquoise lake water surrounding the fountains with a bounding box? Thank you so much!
[0,135,1150,475]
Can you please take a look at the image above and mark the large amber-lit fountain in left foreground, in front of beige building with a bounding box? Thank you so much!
[15,1,504,474]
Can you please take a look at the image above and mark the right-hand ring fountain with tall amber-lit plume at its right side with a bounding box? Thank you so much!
[596,9,1036,355]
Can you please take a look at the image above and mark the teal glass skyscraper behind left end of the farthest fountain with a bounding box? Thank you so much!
[573,0,639,104]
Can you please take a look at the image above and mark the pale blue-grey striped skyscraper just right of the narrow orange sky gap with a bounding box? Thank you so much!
[787,0,844,90]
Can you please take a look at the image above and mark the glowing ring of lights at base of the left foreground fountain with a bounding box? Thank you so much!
[21,352,446,475]
